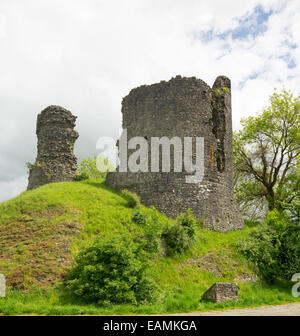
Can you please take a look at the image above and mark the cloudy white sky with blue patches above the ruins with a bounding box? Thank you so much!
[0,0,300,202]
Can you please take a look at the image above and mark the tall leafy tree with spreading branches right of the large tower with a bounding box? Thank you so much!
[233,89,300,218]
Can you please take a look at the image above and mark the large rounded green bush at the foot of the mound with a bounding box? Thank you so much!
[66,236,155,304]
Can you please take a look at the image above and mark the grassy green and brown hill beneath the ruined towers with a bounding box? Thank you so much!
[0,180,299,315]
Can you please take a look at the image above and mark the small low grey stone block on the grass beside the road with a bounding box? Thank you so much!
[202,282,239,302]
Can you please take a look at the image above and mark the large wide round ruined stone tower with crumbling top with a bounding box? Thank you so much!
[106,76,243,231]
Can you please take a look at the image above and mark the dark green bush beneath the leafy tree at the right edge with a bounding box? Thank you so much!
[238,210,300,283]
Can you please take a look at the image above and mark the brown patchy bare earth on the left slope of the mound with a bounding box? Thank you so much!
[0,207,82,289]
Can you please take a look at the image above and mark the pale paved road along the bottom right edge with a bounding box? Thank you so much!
[174,303,300,316]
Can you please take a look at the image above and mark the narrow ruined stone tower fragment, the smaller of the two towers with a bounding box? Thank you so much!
[27,105,78,190]
